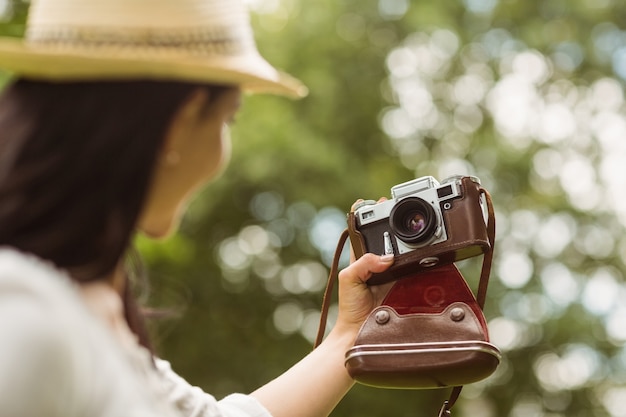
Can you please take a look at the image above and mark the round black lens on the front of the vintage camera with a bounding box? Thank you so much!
[389,197,437,244]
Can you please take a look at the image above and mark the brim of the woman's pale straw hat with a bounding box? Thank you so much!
[0,38,308,98]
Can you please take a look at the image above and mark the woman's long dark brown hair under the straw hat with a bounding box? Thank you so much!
[0,79,229,348]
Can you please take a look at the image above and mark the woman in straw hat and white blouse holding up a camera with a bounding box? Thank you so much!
[0,0,392,417]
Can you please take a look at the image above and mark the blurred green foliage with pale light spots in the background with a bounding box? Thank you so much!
[0,0,626,417]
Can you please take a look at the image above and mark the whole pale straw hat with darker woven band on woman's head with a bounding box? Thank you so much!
[0,0,307,97]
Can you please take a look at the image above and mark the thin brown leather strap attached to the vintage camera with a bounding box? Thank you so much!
[314,187,495,417]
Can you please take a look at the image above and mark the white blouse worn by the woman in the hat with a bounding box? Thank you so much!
[0,248,271,417]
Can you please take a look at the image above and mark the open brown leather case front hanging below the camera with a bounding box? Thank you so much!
[345,265,500,389]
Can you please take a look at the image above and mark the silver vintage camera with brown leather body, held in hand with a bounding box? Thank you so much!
[348,176,491,284]
